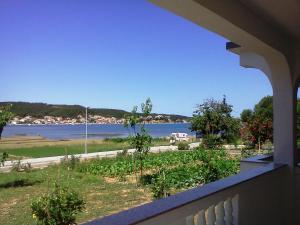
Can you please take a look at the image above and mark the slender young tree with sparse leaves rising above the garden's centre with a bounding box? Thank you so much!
[124,98,152,177]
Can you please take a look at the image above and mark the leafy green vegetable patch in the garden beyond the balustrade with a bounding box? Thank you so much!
[78,148,239,188]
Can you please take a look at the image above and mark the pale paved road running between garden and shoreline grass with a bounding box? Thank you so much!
[0,142,199,172]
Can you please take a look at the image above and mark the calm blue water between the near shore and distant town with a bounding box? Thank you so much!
[2,123,194,140]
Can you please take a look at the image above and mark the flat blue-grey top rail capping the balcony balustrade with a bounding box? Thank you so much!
[84,163,286,225]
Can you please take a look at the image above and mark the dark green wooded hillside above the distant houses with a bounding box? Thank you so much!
[0,102,188,121]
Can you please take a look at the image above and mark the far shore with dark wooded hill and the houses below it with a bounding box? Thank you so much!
[0,102,190,125]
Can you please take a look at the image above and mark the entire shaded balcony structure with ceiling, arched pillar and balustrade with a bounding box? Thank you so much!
[86,0,300,225]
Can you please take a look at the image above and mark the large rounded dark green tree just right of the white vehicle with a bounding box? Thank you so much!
[190,96,240,148]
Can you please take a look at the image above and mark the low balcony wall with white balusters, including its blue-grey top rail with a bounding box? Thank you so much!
[85,159,288,225]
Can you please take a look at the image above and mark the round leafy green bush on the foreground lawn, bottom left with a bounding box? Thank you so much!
[31,183,85,225]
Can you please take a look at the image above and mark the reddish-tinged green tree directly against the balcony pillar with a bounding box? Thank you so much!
[241,96,273,150]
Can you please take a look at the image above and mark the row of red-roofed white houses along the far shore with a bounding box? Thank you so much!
[10,115,187,125]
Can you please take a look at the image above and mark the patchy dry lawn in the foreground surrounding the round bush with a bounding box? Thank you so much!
[0,163,151,225]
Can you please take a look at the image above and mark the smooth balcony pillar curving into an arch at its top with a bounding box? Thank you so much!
[240,51,297,168]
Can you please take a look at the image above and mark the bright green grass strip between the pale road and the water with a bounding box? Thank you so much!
[0,138,169,159]
